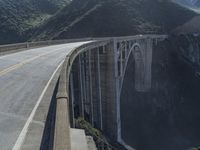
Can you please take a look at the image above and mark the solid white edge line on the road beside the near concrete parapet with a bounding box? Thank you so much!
[12,61,64,150]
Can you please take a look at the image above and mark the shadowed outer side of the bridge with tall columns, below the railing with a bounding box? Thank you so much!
[67,35,167,149]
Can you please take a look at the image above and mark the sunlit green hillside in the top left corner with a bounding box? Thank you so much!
[0,0,70,44]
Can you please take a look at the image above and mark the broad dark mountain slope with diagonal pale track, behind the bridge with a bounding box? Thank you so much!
[32,0,196,40]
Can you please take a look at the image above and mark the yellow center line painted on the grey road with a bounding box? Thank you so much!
[0,48,63,76]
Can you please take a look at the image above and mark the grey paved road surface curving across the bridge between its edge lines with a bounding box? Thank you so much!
[0,42,89,150]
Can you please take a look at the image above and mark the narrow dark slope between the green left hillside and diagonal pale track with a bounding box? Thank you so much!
[29,0,101,39]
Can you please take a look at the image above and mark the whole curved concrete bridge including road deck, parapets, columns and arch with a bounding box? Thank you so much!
[0,35,200,150]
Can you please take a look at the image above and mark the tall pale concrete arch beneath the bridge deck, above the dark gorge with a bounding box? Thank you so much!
[118,42,147,149]
